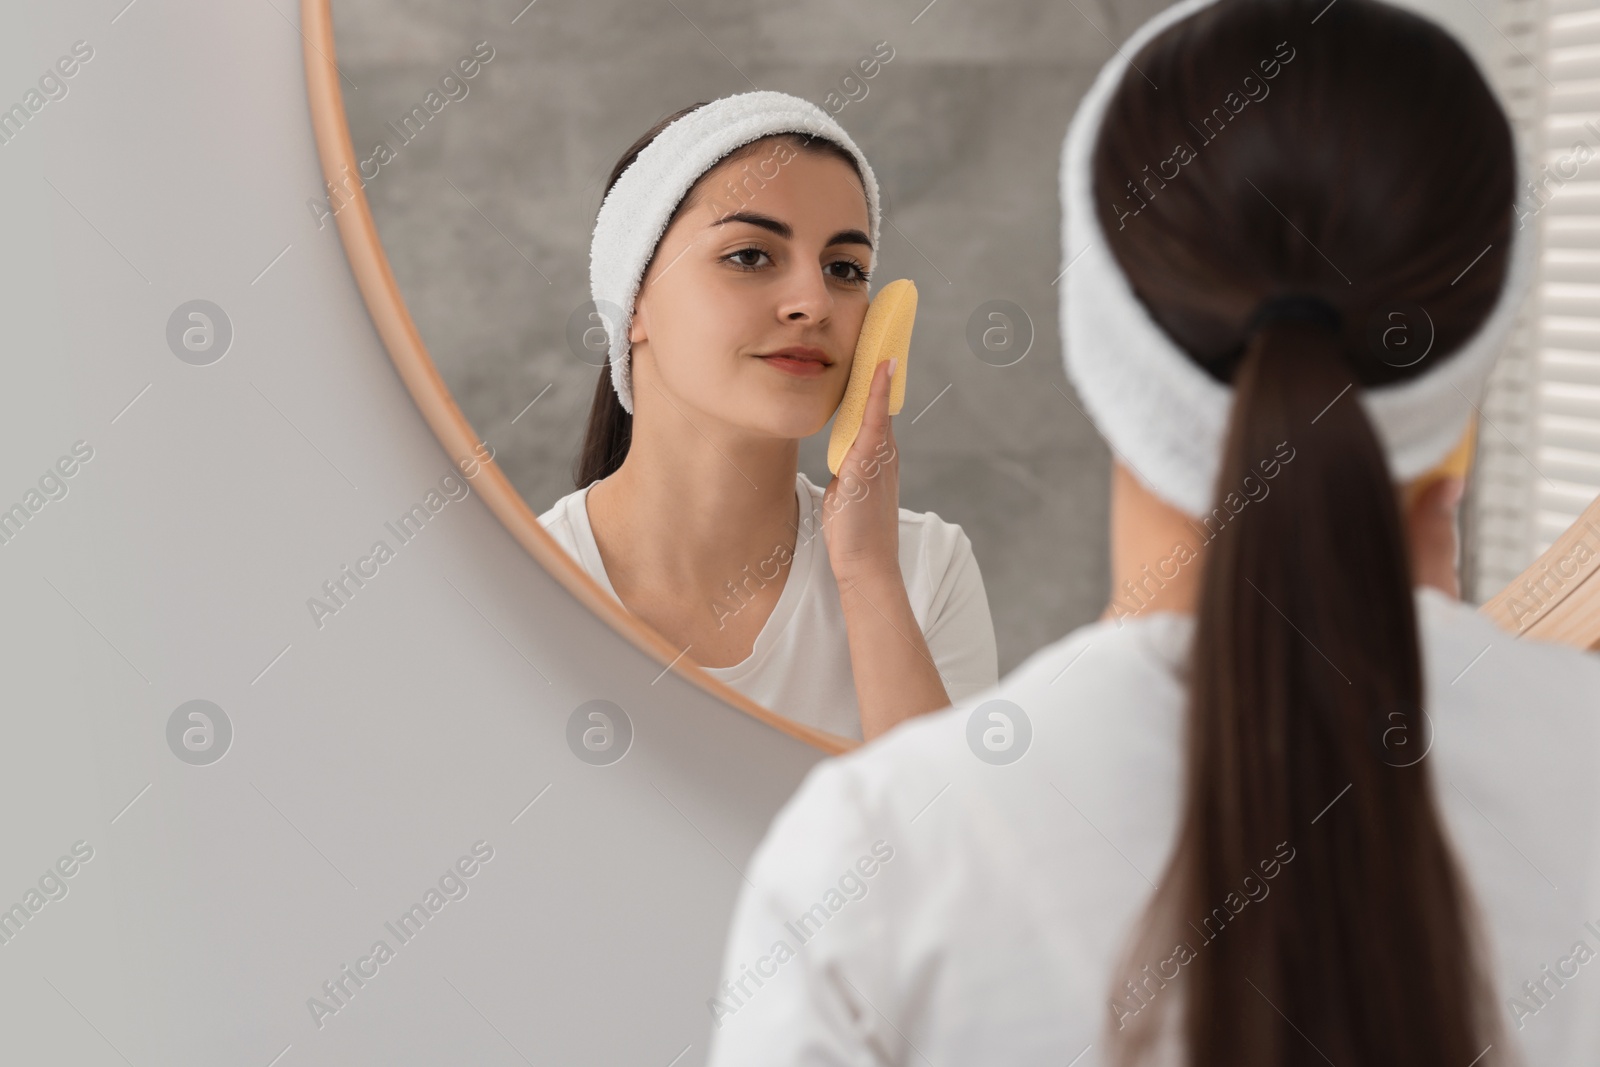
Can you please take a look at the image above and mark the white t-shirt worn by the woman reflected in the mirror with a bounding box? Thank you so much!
[539,472,1000,741]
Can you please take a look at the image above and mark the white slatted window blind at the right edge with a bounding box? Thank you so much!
[1467,0,1600,601]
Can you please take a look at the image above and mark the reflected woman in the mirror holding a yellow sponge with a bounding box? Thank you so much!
[539,91,998,739]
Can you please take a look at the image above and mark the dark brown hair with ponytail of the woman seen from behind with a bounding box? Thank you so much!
[1093,0,1515,1067]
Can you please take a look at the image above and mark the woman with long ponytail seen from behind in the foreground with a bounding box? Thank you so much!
[707,0,1600,1067]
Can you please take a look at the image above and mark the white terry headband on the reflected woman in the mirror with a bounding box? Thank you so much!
[589,90,878,414]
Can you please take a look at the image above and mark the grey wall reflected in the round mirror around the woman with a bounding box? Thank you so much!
[324,0,1163,742]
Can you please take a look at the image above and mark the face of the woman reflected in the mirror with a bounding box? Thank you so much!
[629,141,872,440]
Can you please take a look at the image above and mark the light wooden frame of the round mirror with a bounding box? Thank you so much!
[301,0,1600,755]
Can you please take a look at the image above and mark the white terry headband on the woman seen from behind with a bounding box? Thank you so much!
[1061,0,1536,515]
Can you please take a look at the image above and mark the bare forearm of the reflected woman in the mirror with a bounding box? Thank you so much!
[838,571,950,741]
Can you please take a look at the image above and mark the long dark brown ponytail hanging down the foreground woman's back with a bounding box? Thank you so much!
[1113,322,1491,1067]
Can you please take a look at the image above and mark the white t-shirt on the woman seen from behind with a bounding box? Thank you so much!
[707,589,1600,1067]
